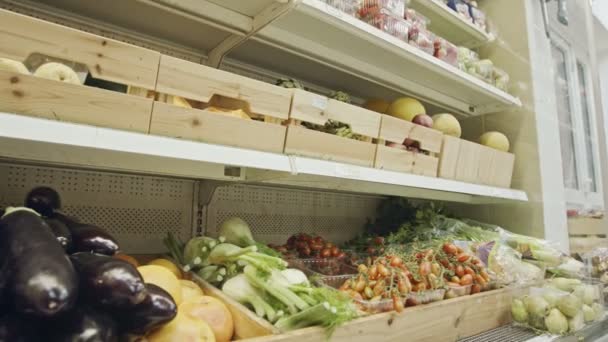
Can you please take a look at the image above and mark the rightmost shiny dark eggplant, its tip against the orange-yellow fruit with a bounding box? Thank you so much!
[116,284,177,335]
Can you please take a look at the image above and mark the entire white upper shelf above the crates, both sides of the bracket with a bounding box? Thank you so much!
[15,0,521,115]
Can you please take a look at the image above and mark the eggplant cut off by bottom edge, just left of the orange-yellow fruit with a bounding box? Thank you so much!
[45,307,118,342]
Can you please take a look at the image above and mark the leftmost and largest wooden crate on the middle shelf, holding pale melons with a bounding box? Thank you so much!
[0,10,160,133]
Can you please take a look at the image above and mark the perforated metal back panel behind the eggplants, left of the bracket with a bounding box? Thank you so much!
[0,164,195,253]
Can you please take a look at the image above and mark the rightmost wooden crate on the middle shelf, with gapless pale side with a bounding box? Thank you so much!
[439,135,515,188]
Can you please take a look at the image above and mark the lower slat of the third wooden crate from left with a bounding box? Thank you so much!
[285,125,376,166]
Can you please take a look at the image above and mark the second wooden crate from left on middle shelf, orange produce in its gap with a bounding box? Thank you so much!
[150,55,291,153]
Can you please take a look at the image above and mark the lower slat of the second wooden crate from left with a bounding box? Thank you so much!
[150,102,286,153]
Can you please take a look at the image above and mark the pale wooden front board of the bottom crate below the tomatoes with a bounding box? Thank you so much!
[239,289,525,342]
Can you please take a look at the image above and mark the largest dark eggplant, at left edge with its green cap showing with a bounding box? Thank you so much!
[0,208,78,317]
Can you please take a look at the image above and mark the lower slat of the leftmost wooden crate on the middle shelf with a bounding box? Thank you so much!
[0,71,152,133]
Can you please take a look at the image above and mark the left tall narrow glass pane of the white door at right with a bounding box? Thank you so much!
[551,44,579,189]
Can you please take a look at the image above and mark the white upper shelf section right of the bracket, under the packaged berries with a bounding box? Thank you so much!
[238,0,521,115]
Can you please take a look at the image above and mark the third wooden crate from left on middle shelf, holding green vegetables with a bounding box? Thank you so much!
[285,89,380,167]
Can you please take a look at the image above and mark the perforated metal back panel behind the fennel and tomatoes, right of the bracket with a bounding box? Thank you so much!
[205,184,380,244]
